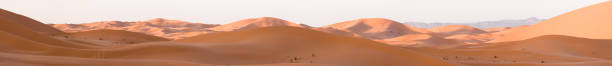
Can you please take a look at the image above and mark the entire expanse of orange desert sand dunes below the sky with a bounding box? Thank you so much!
[0,1,612,66]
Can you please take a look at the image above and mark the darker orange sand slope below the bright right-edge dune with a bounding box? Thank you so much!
[478,35,612,60]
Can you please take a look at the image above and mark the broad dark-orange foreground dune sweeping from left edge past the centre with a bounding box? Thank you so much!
[0,9,457,66]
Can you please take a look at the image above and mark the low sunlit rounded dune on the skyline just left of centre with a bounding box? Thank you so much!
[209,17,309,31]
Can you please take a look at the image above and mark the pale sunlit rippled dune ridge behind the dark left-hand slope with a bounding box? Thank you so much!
[49,18,218,39]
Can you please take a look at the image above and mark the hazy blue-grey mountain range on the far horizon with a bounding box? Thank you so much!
[404,17,545,29]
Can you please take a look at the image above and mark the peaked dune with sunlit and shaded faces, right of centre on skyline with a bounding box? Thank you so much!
[323,18,429,39]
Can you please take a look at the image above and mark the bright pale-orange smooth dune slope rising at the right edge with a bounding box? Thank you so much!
[493,1,612,42]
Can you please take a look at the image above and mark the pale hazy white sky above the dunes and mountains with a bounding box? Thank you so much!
[0,0,608,26]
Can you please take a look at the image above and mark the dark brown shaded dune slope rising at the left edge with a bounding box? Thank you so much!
[0,11,98,48]
